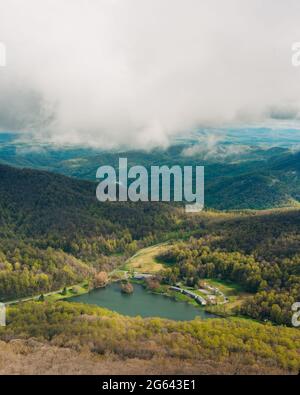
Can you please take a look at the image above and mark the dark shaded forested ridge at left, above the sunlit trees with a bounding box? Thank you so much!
[0,165,175,237]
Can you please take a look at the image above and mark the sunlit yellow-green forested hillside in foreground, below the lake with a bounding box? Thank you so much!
[0,302,300,374]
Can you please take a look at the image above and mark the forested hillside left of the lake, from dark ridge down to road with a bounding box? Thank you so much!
[0,166,176,299]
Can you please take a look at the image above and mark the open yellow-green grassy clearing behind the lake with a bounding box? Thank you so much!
[125,244,170,274]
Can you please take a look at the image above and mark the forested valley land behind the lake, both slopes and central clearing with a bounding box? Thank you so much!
[0,162,300,325]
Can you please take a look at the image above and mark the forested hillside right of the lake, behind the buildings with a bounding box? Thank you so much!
[160,210,300,325]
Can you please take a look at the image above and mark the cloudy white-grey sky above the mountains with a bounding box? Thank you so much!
[0,0,300,148]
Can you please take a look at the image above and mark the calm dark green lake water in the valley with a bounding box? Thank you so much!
[68,283,214,321]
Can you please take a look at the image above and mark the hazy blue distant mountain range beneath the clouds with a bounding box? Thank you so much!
[0,131,300,210]
